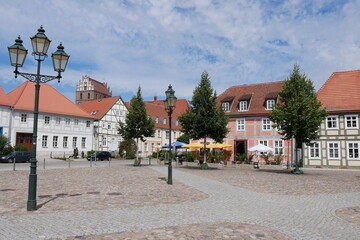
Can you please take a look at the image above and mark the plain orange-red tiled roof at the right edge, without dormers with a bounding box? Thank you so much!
[318,70,360,111]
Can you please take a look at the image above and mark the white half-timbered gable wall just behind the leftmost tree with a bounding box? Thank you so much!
[93,99,128,155]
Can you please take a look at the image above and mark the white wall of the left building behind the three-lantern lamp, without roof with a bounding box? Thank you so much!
[11,110,93,157]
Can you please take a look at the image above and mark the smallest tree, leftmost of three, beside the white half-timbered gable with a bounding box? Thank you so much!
[118,86,155,165]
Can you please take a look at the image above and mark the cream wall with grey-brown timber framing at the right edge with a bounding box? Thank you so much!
[304,113,360,168]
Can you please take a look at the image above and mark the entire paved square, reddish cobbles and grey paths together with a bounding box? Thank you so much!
[0,166,360,240]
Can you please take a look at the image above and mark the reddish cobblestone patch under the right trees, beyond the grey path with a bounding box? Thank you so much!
[181,167,360,195]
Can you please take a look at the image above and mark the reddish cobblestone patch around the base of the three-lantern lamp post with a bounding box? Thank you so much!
[0,166,208,214]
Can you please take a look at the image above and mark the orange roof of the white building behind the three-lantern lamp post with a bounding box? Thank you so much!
[7,81,92,118]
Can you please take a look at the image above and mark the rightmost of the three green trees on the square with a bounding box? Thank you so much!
[269,64,327,173]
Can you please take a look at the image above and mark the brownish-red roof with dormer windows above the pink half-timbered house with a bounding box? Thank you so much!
[217,81,284,115]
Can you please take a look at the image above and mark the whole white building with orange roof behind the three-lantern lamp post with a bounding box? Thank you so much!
[0,82,94,157]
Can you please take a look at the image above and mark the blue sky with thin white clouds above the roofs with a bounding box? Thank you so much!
[0,0,360,101]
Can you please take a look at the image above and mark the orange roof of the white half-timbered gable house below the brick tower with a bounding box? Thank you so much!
[79,97,122,119]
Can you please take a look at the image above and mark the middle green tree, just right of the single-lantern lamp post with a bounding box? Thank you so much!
[179,71,229,169]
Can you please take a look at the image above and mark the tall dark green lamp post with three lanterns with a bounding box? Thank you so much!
[8,26,70,211]
